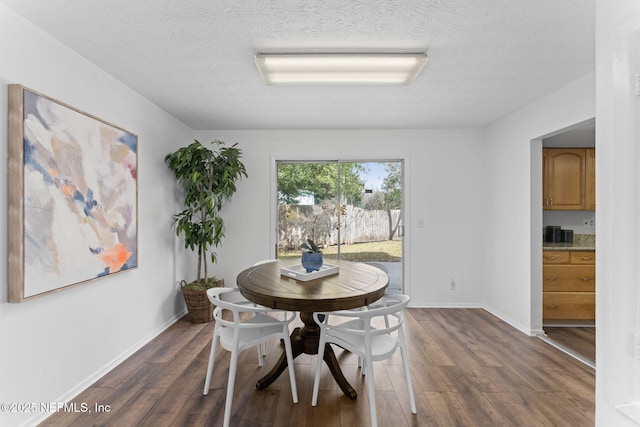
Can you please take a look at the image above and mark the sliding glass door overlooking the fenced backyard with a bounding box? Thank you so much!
[277,161,404,291]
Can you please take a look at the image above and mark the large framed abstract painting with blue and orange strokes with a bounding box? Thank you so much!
[9,85,138,302]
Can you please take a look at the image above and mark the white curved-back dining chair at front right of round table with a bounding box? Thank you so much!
[311,294,416,427]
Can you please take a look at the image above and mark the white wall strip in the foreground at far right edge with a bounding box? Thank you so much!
[596,0,640,426]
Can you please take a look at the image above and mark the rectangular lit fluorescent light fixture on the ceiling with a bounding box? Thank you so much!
[255,53,427,85]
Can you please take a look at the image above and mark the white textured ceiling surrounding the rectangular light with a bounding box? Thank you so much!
[0,0,595,129]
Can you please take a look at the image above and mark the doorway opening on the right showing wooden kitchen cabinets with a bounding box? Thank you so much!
[531,119,596,367]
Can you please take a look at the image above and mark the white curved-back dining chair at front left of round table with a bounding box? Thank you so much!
[203,288,298,427]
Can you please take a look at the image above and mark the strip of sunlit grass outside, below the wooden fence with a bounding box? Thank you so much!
[278,240,402,262]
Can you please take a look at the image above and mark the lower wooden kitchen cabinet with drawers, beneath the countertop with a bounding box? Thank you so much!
[542,250,596,323]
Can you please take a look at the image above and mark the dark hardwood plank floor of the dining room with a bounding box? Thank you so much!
[41,309,595,427]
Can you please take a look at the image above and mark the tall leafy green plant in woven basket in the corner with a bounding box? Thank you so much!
[164,140,247,323]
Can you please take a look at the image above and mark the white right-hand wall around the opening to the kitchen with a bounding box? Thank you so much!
[483,73,595,334]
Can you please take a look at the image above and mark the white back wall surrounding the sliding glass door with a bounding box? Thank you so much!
[196,130,488,306]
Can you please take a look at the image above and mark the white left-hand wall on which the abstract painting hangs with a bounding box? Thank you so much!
[0,5,191,426]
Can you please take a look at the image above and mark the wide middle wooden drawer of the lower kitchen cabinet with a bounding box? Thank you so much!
[542,265,596,292]
